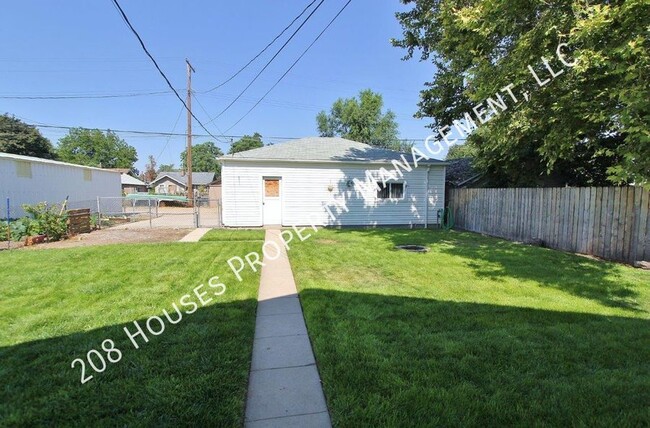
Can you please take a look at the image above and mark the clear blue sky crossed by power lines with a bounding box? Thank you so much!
[0,0,442,169]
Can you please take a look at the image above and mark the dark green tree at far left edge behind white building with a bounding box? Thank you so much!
[0,114,56,159]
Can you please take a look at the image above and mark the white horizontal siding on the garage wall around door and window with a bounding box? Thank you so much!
[221,161,445,227]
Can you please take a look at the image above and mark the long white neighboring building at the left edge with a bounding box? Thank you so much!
[0,153,122,217]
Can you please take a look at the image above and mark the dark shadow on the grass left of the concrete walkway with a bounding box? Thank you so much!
[0,300,256,426]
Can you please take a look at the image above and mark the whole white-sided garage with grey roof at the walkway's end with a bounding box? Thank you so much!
[220,137,445,227]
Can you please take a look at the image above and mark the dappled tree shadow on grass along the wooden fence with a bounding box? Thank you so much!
[324,228,641,311]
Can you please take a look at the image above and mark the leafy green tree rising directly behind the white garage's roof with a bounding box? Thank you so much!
[316,89,399,148]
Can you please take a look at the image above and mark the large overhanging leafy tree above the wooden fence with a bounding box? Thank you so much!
[393,0,650,185]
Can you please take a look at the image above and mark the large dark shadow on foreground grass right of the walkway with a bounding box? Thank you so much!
[300,289,650,427]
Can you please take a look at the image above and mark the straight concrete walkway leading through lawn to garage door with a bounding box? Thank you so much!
[245,230,331,427]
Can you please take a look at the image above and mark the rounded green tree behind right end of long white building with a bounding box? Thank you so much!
[58,128,138,170]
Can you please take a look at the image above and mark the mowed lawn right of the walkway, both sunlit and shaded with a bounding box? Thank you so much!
[289,230,650,427]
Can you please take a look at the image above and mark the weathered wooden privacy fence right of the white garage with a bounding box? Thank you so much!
[449,187,650,263]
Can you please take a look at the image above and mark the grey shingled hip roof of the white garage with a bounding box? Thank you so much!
[220,137,443,164]
